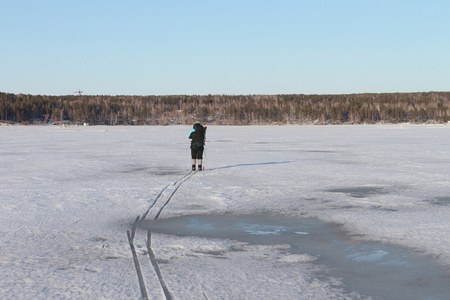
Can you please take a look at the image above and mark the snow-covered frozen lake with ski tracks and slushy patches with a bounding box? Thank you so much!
[0,125,450,300]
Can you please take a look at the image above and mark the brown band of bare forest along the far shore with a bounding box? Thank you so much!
[0,92,450,125]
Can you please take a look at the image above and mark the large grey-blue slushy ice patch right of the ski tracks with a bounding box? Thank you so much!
[140,214,450,300]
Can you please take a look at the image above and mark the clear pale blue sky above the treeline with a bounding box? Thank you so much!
[0,0,450,95]
